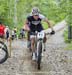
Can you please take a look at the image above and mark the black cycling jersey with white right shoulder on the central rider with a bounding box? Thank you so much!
[27,14,45,32]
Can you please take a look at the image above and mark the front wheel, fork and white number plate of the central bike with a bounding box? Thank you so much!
[36,32,45,69]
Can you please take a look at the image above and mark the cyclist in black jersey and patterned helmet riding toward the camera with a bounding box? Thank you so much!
[24,7,55,60]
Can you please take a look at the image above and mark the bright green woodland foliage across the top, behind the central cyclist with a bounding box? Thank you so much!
[0,0,72,29]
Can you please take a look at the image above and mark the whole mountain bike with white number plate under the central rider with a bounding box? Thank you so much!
[30,31,54,69]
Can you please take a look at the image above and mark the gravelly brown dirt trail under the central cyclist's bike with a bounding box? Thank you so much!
[0,21,72,75]
